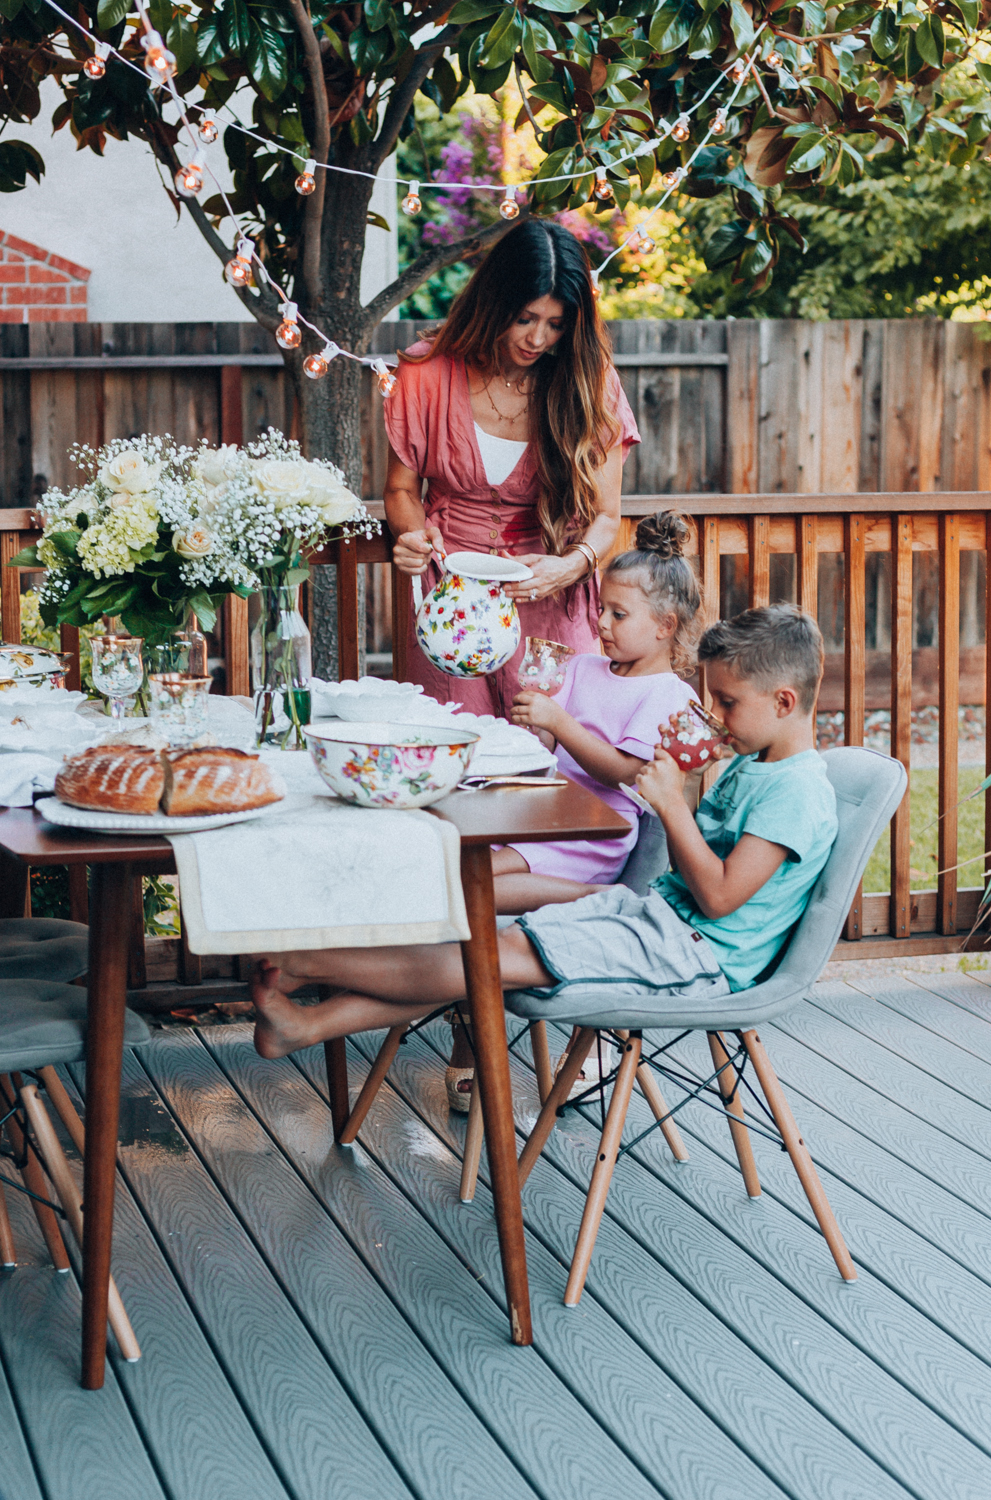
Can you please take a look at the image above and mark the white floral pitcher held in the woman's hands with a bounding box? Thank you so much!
[412,552,534,677]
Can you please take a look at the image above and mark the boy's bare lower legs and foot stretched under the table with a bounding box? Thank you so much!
[252,927,553,1058]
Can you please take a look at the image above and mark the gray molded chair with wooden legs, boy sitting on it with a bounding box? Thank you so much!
[505,747,907,1307]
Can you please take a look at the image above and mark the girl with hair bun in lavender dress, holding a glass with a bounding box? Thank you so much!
[492,510,702,915]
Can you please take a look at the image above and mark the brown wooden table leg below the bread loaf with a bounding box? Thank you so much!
[82,864,132,1391]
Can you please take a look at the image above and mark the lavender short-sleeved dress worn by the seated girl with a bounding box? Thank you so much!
[510,656,696,885]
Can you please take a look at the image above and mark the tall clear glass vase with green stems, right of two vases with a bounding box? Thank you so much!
[250,585,313,750]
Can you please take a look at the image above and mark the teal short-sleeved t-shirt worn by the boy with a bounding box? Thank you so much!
[654,750,838,990]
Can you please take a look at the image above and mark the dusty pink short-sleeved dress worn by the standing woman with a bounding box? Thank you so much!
[384,342,640,719]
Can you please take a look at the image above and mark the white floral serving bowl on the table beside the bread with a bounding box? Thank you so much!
[303,722,478,807]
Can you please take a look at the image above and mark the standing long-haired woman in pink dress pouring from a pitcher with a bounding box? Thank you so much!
[385,219,640,717]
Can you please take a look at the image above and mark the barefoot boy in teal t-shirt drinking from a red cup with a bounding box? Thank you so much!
[253,605,837,1058]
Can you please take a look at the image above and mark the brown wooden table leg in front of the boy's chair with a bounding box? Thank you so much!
[462,845,534,1344]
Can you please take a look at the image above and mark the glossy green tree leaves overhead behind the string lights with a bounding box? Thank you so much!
[0,0,991,312]
